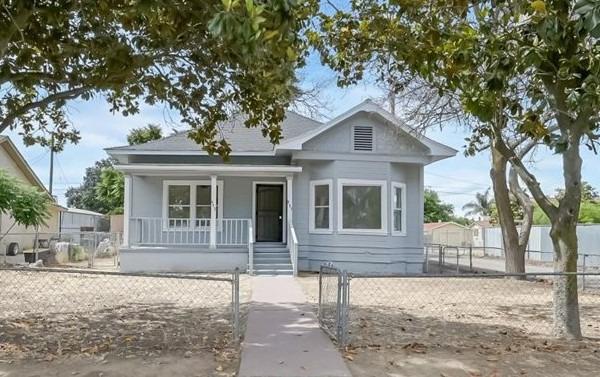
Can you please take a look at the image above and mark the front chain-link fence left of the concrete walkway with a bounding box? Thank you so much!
[0,267,244,360]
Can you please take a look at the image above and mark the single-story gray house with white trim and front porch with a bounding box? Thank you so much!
[107,101,456,274]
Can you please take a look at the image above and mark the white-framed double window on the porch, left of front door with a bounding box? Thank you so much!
[163,180,223,228]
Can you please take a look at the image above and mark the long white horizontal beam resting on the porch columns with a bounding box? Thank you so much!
[115,164,302,176]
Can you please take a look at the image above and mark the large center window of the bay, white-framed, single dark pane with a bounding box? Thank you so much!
[337,179,388,234]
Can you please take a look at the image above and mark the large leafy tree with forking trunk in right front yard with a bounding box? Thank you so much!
[310,0,600,338]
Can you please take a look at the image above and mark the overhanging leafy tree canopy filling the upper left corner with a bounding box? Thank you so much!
[0,0,316,155]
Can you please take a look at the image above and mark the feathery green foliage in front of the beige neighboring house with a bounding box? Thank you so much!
[0,169,50,227]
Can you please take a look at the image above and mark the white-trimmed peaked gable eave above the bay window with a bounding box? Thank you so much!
[278,99,458,161]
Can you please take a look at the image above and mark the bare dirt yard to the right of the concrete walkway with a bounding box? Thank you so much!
[300,275,600,377]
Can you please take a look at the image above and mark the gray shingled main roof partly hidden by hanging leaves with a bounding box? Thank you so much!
[106,111,322,155]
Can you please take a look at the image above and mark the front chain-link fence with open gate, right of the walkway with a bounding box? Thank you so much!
[316,266,600,347]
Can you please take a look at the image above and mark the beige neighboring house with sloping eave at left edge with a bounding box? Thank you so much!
[0,135,63,255]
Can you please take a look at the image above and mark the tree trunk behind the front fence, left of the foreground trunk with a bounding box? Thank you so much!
[490,142,527,273]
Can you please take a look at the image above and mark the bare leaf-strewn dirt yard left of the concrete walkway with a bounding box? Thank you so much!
[0,270,250,377]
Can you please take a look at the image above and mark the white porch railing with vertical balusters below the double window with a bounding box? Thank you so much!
[129,217,252,246]
